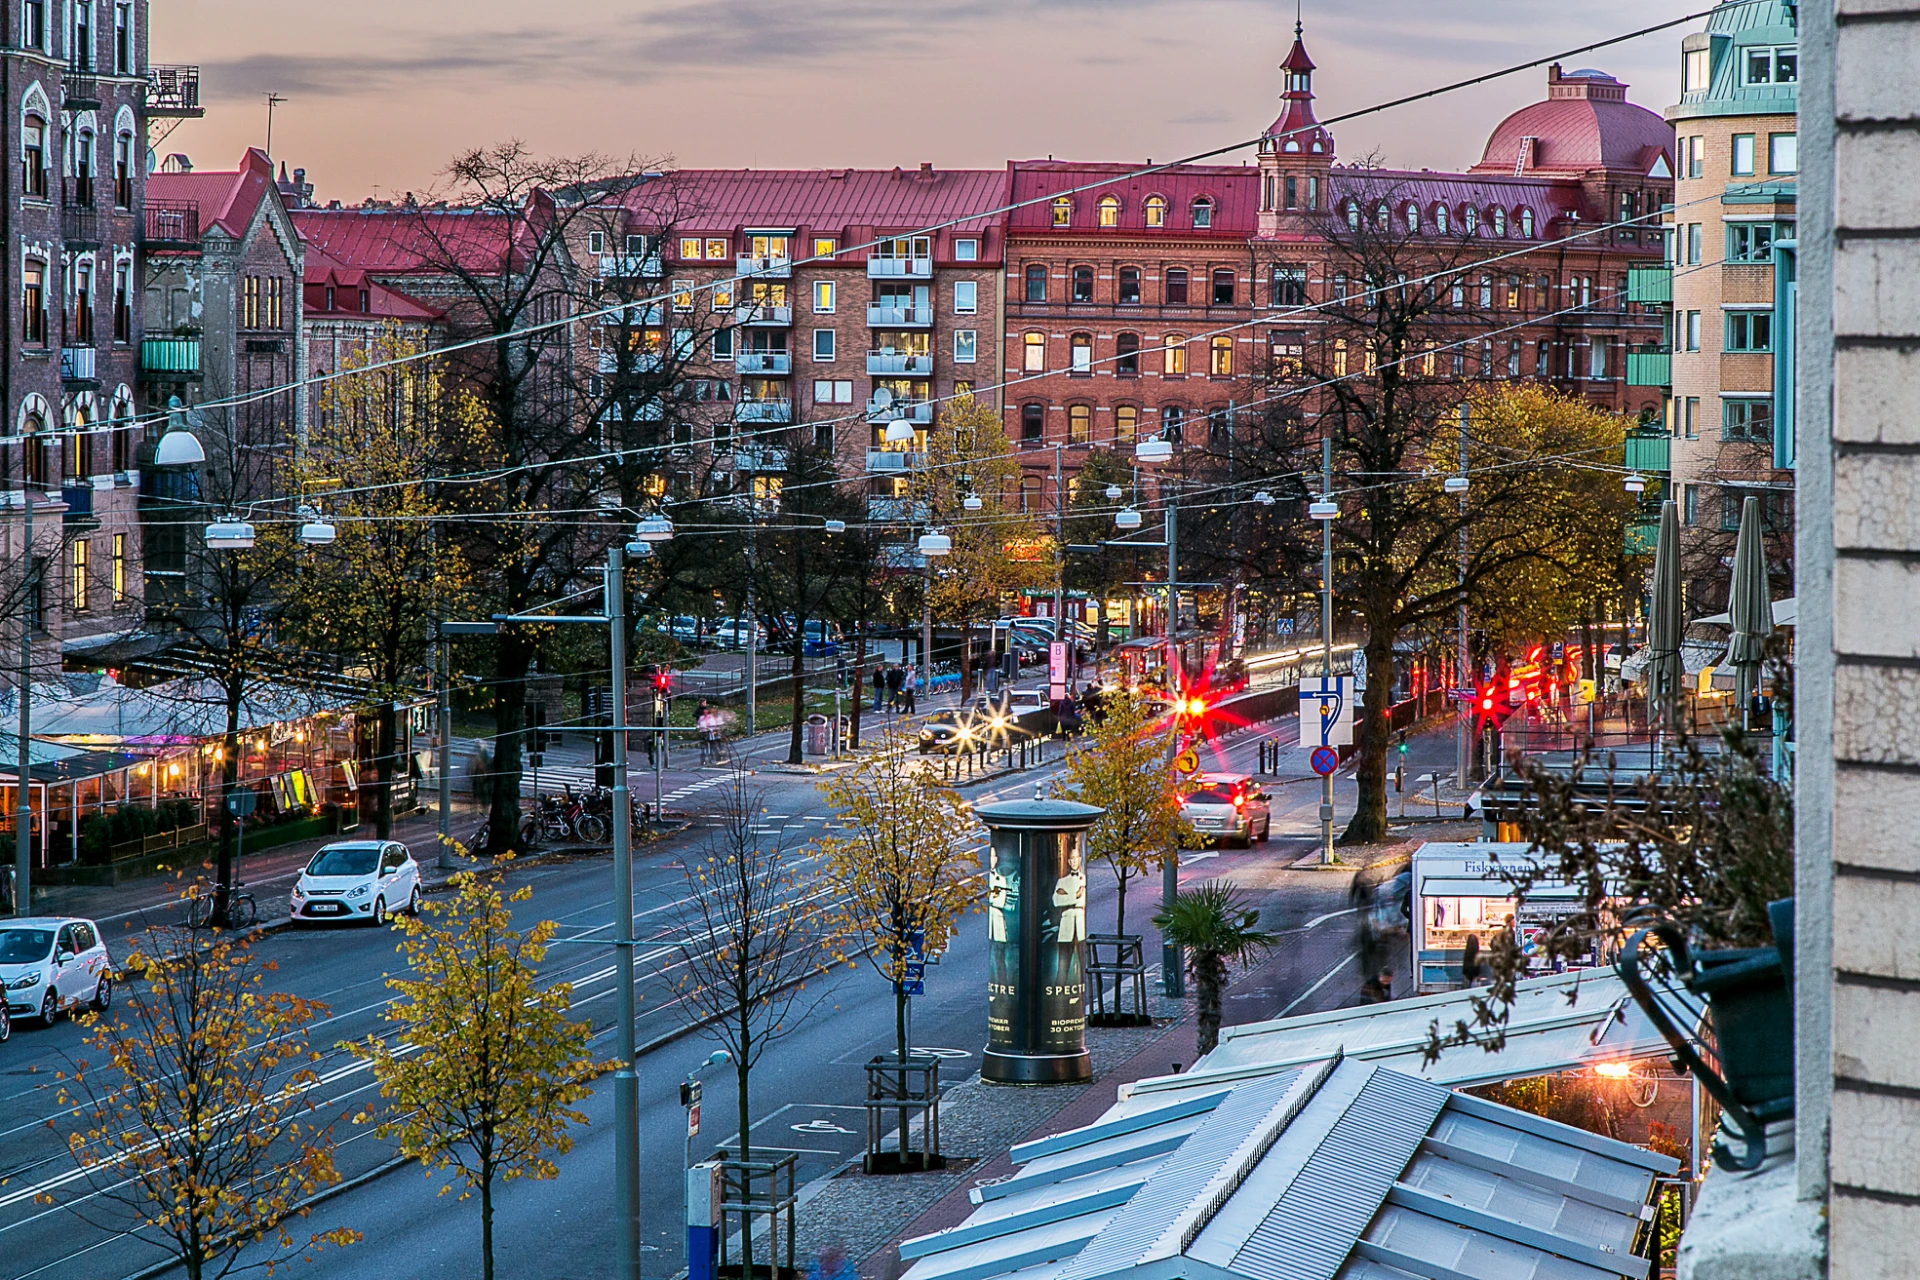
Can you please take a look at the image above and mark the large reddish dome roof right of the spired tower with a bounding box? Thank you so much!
[1473,65,1674,173]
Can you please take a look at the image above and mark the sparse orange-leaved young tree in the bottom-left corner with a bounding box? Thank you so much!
[58,929,359,1280]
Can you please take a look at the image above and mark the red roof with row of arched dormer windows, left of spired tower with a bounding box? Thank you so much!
[1008,159,1260,240]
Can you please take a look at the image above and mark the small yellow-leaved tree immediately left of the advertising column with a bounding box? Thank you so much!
[814,733,981,1063]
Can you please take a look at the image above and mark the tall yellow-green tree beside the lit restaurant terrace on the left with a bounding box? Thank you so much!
[282,328,480,841]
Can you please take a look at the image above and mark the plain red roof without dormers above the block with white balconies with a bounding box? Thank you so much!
[626,167,1006,261]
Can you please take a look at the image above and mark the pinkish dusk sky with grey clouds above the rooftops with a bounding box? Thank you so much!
[152,0,1707,203]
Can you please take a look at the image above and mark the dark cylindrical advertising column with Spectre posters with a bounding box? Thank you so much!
[973,800,1104,1084]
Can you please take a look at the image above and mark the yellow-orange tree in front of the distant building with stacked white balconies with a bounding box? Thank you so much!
[914,397,1058,700]
